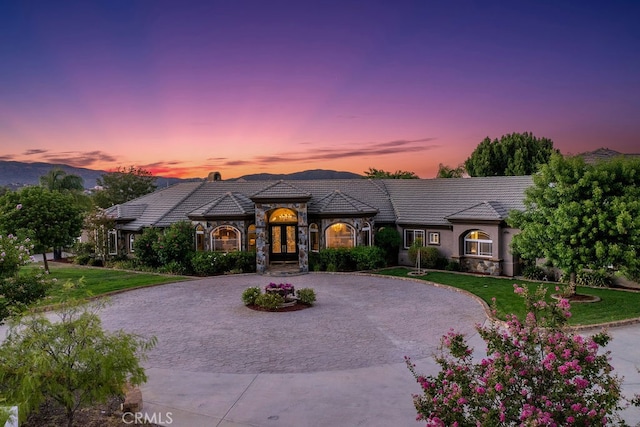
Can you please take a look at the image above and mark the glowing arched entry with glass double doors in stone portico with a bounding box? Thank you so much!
[269,208,298,263]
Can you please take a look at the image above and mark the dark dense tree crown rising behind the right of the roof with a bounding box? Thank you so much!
[464,132,559,176]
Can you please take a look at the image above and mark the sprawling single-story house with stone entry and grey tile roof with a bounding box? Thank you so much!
[107,176,532,276]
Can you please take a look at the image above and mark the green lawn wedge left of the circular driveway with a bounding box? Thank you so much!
[23,263,192,305]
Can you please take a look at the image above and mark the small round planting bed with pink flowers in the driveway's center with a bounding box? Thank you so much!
[242,282,316,311]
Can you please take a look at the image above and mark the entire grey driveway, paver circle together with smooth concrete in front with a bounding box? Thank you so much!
[0,273,640,427]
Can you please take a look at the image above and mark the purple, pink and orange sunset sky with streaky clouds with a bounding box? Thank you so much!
[0,0,640,179]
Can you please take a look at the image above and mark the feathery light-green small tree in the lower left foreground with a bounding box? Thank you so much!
[0,283,156,427]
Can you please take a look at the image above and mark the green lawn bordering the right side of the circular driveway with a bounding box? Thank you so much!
[378,267,640,326]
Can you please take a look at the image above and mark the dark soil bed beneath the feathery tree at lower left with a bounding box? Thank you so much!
[20,396,160,427]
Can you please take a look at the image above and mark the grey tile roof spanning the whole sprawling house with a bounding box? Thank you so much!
[110,176,532,230]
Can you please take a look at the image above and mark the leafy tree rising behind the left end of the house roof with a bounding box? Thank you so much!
[93,166,156,208]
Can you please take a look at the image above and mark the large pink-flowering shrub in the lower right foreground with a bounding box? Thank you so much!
[406,285,622,426]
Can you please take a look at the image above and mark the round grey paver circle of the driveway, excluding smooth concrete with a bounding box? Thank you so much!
[101,273,486,374]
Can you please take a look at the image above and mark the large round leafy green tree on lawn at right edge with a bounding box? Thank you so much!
[508,154,640,293]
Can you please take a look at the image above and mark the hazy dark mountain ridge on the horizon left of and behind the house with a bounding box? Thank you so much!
[0,160,362,189]
